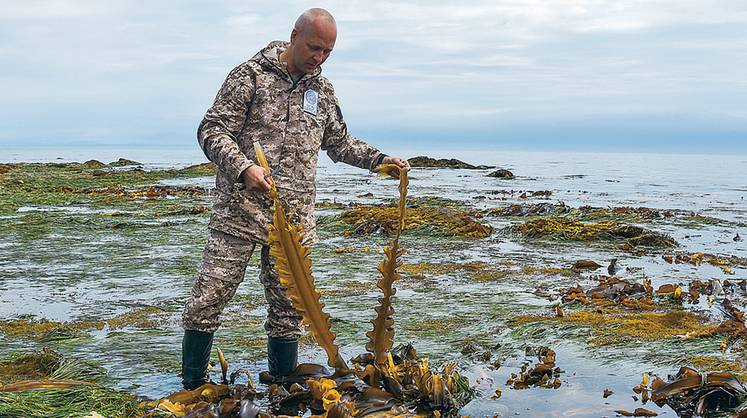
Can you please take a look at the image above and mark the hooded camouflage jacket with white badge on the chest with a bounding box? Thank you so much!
[197,41,383,244]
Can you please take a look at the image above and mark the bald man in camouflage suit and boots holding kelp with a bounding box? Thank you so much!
[182,9,410,389]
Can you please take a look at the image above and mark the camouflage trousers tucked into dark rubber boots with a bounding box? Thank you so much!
[182,229,301,338]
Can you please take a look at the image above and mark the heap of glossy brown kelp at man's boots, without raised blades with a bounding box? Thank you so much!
[145,345,475,418]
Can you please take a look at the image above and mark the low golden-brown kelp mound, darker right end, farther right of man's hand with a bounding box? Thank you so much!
[514,218,678,248]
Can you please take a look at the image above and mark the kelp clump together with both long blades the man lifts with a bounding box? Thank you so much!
[256,158,469,416]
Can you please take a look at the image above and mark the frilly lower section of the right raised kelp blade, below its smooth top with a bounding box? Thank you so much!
[366,240,405,365]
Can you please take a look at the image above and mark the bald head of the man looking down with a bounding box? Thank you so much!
[283,8,337,75]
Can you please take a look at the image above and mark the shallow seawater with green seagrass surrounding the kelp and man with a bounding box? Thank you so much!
[0,152,747,417]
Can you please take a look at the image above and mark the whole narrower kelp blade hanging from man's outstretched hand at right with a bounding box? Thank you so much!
[366,164,409,365]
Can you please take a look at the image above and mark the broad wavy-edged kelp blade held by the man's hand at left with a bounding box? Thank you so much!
[254,142,347,369]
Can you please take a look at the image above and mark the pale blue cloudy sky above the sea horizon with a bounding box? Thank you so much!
[0,0,747,153]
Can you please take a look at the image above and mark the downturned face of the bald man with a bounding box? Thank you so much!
[290,22,337,73]
